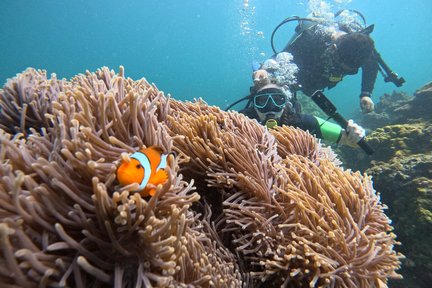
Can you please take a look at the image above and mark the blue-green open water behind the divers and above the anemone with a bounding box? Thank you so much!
[0,0,432,114]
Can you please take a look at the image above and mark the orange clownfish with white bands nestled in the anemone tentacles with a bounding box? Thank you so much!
[116,146,168,197]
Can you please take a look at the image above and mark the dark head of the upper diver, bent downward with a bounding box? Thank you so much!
[336,32,374,71]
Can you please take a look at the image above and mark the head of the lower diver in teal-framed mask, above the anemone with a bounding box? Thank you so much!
[253,84,288,122]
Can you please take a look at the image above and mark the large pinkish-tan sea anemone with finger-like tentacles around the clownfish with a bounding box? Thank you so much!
[0,67,402,287]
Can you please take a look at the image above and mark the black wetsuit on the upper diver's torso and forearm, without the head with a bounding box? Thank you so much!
[284,26,378,96]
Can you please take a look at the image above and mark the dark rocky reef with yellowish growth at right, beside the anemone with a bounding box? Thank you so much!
[341,82,432,288]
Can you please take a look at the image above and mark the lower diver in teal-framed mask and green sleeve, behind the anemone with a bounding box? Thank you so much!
[240,83,365,147]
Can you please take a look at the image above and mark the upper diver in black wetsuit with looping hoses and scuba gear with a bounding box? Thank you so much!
[251,10,405,113]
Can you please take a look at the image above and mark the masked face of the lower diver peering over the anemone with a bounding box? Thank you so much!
[253,91,287,122]
